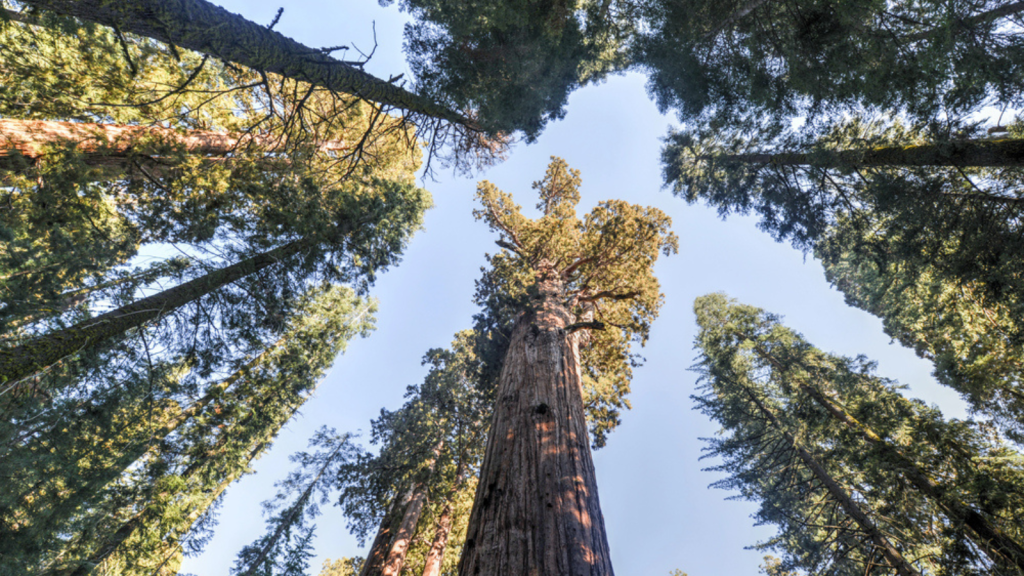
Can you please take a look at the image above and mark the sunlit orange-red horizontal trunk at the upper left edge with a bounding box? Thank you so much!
[0,119,345,169]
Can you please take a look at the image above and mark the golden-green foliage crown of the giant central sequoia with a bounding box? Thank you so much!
[474,158,678,446]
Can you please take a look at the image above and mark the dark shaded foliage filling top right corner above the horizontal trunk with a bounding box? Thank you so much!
[634,0,1024,123]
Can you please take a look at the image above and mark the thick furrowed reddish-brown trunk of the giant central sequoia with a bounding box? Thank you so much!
[459,269,612,576]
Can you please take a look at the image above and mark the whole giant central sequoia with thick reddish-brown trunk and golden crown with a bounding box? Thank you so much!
[459,159,677,575]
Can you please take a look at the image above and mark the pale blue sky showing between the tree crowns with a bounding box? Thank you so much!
[182,0,965,576]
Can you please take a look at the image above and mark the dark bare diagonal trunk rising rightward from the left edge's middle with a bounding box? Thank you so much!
[0,239,312,395]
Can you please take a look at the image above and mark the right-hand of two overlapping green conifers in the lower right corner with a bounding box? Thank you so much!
[695,294,1024,574]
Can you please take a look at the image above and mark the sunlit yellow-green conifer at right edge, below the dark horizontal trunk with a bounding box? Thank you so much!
[815,234,1024,445]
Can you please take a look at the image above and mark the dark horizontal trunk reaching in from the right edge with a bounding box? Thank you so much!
[696,138,1024,168]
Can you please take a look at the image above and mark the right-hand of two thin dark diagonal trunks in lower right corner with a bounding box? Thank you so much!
[748,338,1024,571]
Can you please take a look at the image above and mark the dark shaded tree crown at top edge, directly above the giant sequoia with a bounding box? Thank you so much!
[397,0,625,140]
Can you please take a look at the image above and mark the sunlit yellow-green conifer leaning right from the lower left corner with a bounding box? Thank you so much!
[22,287,373,575]
